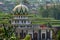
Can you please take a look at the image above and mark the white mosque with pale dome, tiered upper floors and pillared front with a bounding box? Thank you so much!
[11,4,52,40]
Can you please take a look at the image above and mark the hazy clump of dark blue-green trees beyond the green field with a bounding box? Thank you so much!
[39,5,60,20]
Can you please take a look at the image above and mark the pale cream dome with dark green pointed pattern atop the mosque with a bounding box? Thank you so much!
[13,4,28,13]
